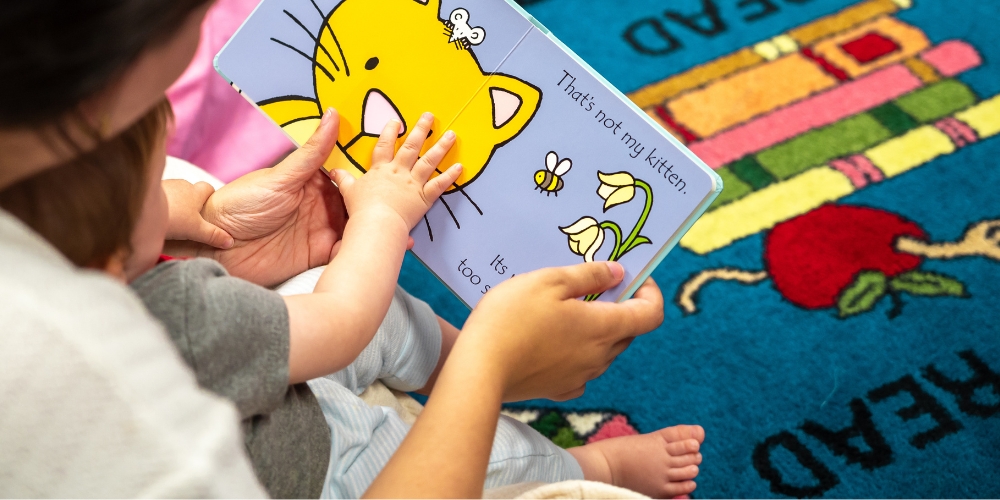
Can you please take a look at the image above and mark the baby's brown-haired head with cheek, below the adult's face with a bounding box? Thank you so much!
[0,99,172,281]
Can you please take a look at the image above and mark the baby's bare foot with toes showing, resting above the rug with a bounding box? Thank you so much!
[568,425,705,498]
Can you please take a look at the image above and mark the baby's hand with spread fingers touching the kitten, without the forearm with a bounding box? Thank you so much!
[331,113,462,230]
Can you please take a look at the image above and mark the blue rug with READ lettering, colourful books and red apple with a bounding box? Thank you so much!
[401,0,1000,498]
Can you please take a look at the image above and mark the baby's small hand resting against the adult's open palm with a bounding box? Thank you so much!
[163,179,234,249]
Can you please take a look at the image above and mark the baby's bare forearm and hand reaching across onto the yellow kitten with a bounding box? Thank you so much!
[285,113,461,383]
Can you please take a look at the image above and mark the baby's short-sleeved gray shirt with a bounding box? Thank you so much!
[132,259,331,498]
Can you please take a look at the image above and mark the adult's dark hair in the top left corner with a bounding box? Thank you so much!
[0,0,209,128]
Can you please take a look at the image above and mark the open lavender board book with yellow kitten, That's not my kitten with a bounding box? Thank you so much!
[215,0,722,306]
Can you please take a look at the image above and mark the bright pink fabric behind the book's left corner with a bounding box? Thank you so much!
[167,0,295,182]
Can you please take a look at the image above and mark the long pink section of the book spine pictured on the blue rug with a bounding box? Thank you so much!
[688,64,923,168]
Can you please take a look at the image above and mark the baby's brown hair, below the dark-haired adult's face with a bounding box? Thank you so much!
[0,99,173,268]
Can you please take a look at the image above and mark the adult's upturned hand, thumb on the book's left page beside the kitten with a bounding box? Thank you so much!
[168,110,347,286]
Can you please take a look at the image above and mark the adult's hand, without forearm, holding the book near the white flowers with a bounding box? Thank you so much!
[460,262,663,401]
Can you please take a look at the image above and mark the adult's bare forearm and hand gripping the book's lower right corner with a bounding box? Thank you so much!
[365,262,663,498]
